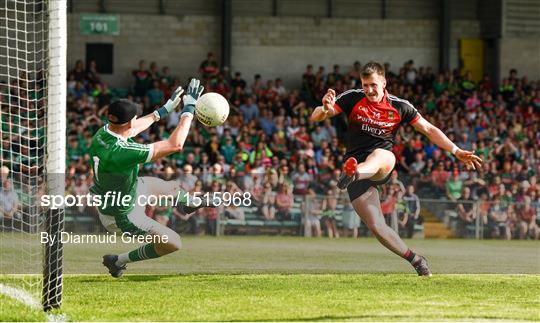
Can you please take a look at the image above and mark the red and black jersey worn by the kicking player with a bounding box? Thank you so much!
[334,89,420,155]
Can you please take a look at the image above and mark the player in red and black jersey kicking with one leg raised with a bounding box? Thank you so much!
[311,62,482,276]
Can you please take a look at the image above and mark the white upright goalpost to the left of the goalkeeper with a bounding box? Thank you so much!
[43,0,67,310]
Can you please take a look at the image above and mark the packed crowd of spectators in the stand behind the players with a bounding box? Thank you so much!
[0,53,540,239]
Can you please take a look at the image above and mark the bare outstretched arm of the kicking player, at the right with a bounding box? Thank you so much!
[412,117,482,169]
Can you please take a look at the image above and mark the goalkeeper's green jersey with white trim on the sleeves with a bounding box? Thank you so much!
[89,126,153,216]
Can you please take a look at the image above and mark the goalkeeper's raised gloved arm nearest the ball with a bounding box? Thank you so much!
[152,79,204,161]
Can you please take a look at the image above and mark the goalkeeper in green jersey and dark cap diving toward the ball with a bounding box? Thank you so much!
[90,79,207,277]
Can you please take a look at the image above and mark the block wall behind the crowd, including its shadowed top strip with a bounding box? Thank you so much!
[68,0,488,86]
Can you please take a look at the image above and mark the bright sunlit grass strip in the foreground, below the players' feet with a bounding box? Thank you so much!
[2,274,540,321]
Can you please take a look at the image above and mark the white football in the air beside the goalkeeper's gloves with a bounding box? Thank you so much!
[195,92,229,127]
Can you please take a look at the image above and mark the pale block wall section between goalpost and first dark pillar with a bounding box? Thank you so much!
[68,14,220,87]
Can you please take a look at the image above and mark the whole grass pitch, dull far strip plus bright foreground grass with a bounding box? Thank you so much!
[0,237,540,321]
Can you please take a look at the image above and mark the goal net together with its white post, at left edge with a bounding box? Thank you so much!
[0,0,67,310]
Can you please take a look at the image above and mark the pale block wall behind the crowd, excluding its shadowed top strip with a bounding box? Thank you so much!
[68,14,479,86]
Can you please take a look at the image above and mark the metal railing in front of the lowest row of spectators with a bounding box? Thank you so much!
[61,192,540,239]
